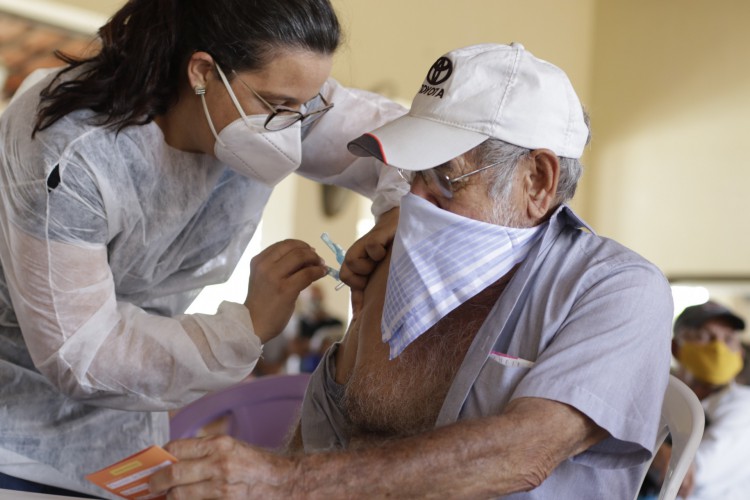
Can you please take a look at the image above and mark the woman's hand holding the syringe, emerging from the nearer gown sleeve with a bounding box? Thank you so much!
[245,240,326,343]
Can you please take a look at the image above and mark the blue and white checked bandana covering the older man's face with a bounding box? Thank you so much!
[381,193,543,359]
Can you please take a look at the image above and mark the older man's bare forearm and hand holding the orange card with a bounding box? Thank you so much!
[151,398,607,498]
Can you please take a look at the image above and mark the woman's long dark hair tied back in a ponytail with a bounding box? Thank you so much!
[34,0,340,133]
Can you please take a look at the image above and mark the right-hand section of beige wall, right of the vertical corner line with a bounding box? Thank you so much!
[589,0,750,276]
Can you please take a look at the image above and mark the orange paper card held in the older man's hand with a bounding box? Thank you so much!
[86,446,177,500]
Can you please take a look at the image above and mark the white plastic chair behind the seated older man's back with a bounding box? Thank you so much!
[636,375,706,500]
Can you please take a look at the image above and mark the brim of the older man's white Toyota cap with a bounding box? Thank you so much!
[347,115,488,170]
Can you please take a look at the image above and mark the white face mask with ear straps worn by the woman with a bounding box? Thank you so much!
[200,65,302,186]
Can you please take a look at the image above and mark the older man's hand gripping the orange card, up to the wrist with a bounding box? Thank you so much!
[149,436,294,500]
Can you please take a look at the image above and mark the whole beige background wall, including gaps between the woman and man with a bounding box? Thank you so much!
[0,0,750,322]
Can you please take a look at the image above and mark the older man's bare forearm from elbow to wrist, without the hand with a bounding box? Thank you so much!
[298,398,606,498]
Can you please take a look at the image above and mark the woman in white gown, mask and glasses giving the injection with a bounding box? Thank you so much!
[0,0,403,496]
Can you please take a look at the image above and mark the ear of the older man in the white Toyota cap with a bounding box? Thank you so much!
[523,149,560,220]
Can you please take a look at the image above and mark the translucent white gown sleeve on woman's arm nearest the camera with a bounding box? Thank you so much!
[0,114,261,410]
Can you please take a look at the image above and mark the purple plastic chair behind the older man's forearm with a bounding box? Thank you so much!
[170,373,310,449]
